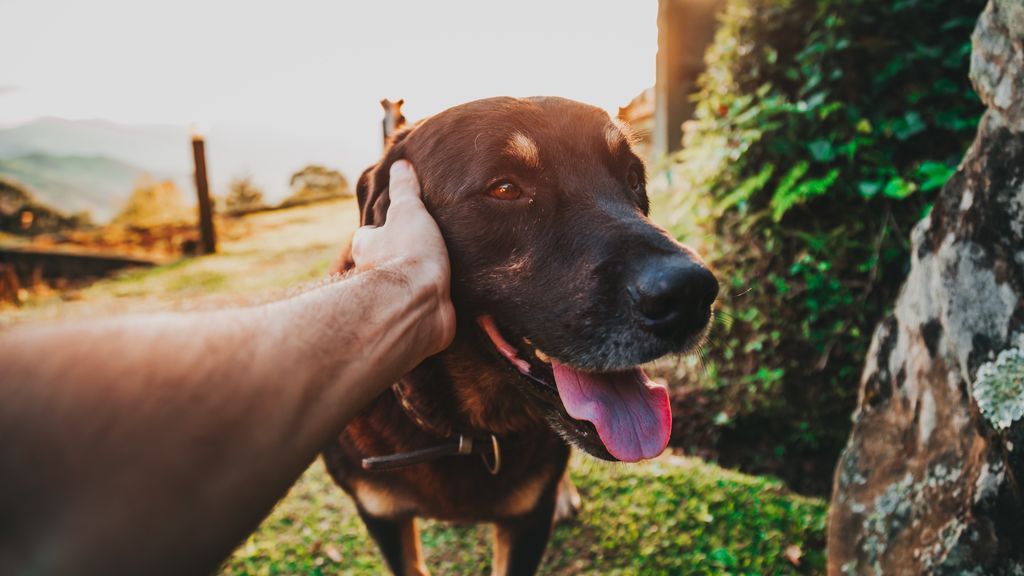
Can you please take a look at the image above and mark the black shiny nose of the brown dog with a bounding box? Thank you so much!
[627,258,718,336]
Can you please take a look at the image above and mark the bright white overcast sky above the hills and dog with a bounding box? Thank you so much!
[0,0,657,193]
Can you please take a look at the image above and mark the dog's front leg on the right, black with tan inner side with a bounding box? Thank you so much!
[490,489,557,576]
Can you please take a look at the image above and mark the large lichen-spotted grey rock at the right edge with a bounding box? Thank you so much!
[828,0,1024,575]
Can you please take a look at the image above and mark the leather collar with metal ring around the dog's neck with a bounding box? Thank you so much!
[362,380,502,475]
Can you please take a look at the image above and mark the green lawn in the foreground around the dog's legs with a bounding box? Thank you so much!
[221,457,825,575]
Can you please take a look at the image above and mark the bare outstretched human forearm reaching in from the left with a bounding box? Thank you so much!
[0,271,436,573]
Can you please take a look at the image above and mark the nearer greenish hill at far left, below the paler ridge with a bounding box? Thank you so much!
[0,153,180,222]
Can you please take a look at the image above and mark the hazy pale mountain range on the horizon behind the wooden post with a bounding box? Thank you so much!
[0,117,360,222]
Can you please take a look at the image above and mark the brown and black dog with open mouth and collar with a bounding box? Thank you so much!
[324,97,718,575]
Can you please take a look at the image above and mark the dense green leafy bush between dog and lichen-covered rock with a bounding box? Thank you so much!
[670,0,984,483]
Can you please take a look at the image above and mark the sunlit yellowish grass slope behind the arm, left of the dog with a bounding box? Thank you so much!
[0,200,358,326]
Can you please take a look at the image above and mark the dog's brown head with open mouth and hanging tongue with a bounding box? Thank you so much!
[357,97,718,461]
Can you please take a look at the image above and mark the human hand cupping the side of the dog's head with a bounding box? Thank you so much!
[351,160,455,358]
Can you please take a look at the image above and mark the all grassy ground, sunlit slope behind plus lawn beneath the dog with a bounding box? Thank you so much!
[0,200,825,575]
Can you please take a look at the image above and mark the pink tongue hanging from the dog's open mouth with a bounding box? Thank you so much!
[551,360,672,462]
